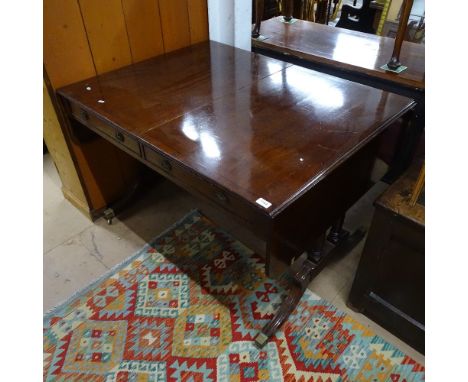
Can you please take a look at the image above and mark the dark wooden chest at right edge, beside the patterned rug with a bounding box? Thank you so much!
[349,166,425,353]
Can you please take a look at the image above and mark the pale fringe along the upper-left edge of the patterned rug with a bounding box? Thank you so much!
[43,209,202,321]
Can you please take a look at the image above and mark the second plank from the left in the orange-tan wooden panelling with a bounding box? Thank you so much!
[80,0,132,74]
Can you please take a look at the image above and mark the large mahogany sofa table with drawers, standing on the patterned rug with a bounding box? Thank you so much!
[58,42,414,346]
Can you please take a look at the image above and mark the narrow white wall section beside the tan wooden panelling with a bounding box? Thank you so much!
[208,0,252,51]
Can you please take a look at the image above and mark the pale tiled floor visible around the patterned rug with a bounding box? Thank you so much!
[44,155,424,363]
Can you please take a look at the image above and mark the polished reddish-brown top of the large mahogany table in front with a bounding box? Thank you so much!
[59,42,414,216]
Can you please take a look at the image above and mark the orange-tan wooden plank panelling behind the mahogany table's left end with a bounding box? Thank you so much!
[43,0,208,217]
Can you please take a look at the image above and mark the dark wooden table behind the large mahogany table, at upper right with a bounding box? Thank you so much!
[252,17,425,182]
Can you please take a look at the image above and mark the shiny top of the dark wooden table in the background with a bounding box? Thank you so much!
[252,16,425,89]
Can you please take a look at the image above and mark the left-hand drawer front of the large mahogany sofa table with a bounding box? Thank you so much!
[70,103,141,155]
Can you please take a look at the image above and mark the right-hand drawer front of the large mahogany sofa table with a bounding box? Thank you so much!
[142,145,264,228]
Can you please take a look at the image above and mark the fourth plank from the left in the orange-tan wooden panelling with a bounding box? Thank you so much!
[159,0,190,52]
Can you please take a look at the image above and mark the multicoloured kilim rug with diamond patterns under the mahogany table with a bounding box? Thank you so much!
[44,212,424,382]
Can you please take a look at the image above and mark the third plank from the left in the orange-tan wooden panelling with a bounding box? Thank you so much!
[122,0,164,62]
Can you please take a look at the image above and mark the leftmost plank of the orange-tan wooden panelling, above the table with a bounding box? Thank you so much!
[43,0,96,88]
